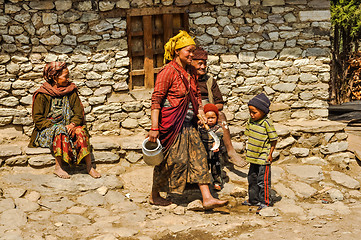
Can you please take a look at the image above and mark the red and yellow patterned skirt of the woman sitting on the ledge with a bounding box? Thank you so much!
[35,124,91,165]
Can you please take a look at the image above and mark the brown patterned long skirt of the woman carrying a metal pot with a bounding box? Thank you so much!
[153,125,211,194]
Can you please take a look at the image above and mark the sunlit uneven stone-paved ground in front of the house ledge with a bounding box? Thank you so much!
[0,154,361,240]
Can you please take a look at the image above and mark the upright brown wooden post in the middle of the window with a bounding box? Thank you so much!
[143,16,154,88]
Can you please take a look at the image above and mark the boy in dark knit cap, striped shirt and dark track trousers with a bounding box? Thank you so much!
[243,93,278,213]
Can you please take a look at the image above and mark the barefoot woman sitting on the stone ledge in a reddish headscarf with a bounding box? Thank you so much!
[29,62,100,178]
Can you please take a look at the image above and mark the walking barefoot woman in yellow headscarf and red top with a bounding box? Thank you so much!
[148,31,228,209]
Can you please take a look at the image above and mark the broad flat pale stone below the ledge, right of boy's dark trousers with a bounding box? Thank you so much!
[287,165,324,184]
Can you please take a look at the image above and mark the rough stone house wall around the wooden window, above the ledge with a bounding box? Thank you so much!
[0,0,331,138]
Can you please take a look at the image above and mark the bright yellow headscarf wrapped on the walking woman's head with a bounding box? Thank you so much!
[164,30,196,63]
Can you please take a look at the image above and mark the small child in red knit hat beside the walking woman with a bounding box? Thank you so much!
[199,103,227,191]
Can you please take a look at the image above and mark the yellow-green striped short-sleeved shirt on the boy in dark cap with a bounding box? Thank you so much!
[244,117,278,165]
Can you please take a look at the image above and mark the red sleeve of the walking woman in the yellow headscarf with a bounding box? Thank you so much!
[151,66,175,110]
